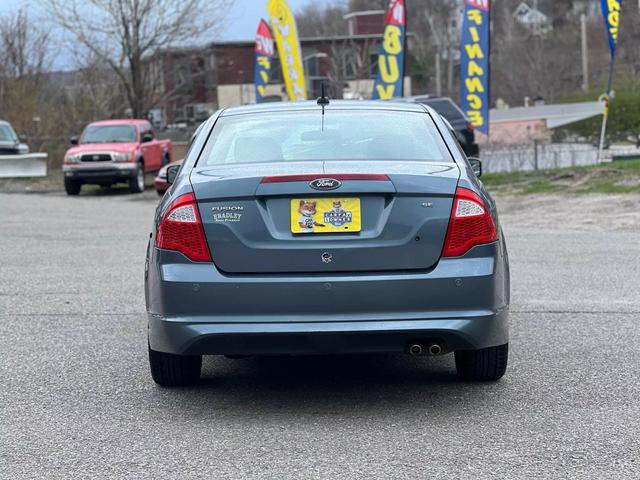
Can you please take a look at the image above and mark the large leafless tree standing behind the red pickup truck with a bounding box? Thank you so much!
[43,0,230,117]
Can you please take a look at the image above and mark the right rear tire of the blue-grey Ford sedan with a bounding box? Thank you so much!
[455,343,509,382]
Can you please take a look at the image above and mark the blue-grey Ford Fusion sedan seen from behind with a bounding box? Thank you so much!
[145,100,509,386]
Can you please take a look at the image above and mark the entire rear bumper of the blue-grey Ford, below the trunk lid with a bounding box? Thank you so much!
[145,243,509,355]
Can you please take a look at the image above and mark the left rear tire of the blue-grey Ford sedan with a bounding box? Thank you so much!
[149,347,202,387]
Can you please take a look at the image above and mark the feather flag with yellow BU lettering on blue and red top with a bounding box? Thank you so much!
[372,0,407,100]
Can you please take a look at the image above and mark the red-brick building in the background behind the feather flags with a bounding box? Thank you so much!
[147,10,411,125]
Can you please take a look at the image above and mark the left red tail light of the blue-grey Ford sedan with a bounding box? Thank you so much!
[156,193,211,262]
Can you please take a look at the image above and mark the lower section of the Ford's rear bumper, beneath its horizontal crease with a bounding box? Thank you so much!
[149,310,508,355]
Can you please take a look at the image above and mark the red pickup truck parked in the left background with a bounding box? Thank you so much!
[62,120,173,195]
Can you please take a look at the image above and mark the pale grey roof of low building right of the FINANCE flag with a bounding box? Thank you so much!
[490,102,604,128]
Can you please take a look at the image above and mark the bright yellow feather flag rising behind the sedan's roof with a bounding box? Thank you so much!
[267,0,307,101]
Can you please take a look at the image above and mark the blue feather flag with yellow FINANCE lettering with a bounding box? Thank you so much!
[460,0,491,135]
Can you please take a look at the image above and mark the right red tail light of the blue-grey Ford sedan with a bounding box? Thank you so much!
[442,187,498,257]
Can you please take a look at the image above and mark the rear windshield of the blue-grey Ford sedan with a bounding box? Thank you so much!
[201,109,453,165]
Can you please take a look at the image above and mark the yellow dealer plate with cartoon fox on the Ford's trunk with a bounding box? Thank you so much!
[291,198,362,233]
